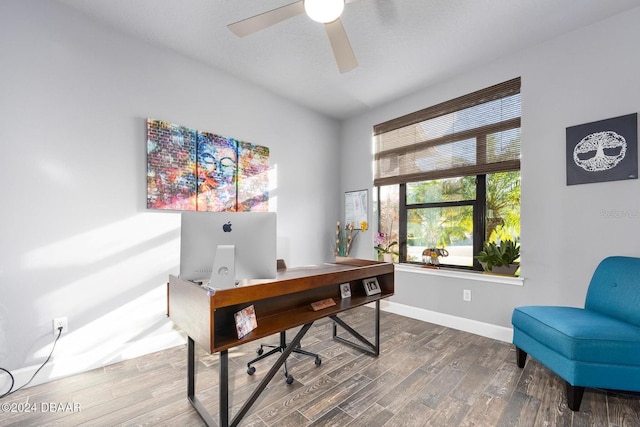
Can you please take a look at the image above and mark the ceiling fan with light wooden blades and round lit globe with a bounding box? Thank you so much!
[227,0,358,73]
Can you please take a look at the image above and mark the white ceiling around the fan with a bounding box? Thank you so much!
[58,0,640,119]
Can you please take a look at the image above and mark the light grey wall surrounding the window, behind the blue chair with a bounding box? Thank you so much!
[342,8,640,334]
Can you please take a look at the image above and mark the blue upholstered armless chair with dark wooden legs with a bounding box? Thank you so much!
[511,256,640,411]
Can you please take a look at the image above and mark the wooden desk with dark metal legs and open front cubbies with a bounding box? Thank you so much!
[169,258,394,427]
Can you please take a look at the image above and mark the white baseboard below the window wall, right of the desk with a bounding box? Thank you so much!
[380,301,513,343]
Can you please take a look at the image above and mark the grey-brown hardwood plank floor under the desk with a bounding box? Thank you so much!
[0,307,640,427]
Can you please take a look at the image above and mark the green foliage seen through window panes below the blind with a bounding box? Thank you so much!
[380,171,520,267]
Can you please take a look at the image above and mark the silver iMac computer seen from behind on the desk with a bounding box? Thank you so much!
[180,212,277,289]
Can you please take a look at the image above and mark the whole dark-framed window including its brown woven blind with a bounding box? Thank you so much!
[374,78,521,269]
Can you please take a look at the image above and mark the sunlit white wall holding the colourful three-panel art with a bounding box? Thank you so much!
[0,0,339,391]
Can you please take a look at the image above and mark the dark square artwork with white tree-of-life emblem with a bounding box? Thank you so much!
[566,113,638,185]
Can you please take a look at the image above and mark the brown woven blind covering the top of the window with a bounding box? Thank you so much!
[373,77,521,186]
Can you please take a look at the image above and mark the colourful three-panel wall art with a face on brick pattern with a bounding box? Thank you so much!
[147,119,269,212]
